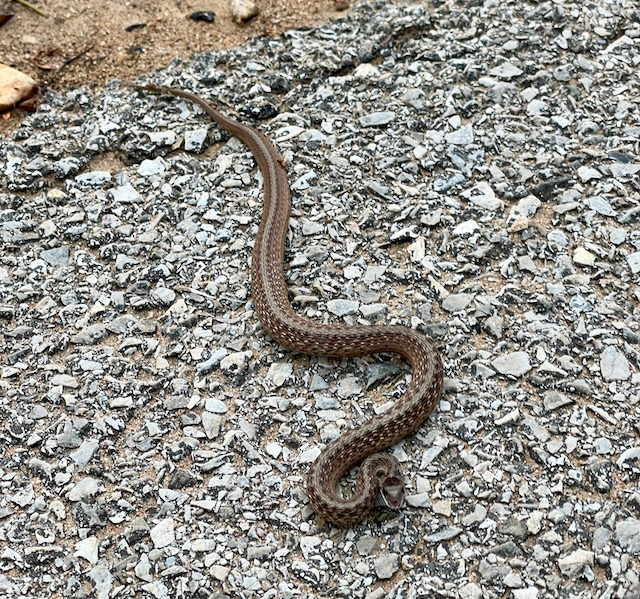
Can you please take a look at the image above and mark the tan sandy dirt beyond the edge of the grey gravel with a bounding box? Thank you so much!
[0,0,344,134]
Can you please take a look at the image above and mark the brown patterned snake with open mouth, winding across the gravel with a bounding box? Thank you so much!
[138,85,443,525]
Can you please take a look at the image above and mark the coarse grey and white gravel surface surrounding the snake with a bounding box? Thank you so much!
[0,0,640,599]
